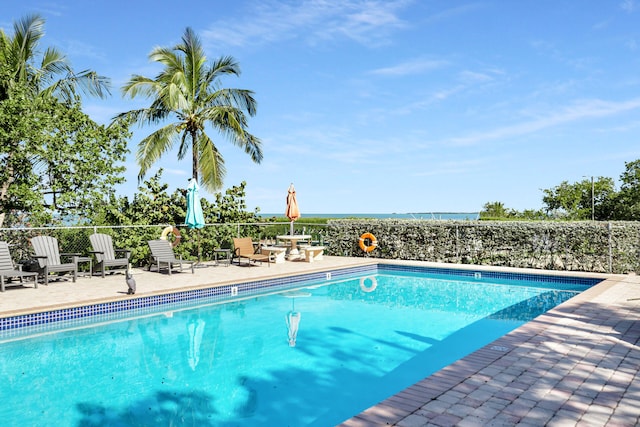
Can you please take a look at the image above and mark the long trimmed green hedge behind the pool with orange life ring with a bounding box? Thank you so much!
[326,219,640,273]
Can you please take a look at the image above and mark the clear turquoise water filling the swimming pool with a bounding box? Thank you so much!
[0,271,588,426]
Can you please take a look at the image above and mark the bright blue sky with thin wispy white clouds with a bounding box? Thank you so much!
[0,0,640,217]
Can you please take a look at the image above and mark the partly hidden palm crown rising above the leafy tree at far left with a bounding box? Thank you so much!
[0,14,109,102]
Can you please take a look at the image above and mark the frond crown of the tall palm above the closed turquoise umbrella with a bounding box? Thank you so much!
[114,28,262,191]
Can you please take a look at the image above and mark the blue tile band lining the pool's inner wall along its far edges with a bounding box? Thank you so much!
[0,264,602,340]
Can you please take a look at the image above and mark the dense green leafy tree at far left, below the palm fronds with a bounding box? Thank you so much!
[0,83,128,225]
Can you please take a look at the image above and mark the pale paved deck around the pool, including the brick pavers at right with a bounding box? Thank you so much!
[0,256,640,427]
